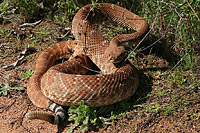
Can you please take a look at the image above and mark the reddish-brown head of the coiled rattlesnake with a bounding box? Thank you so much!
[105,46,126,63]
